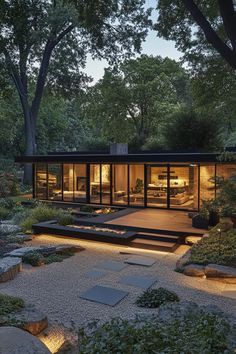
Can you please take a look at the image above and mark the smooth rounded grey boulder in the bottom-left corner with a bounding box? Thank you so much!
[0,327,50,354]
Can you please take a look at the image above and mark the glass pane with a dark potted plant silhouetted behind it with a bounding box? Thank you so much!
[129,165,144,205]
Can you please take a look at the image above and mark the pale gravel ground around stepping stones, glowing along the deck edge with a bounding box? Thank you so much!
[0,235,236,327]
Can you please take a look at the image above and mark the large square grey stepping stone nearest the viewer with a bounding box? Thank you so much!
[80,285,129,306]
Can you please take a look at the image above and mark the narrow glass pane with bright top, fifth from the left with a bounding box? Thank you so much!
[90,164,101,204]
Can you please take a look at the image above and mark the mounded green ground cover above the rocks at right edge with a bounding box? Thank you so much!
[188,224,236,267]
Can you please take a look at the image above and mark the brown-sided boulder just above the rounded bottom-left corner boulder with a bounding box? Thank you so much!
[11,305,48,336]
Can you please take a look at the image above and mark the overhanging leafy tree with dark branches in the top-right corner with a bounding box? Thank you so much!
[155,0,236,70]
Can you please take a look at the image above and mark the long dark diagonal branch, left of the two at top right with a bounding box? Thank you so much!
[183,0,236,69]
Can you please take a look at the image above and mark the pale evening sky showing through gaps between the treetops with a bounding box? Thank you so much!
[86,0,181,83]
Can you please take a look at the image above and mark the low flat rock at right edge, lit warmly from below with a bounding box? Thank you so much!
[205,264,236,284]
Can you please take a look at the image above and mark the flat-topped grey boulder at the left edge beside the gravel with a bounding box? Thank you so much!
[0,257,22,283]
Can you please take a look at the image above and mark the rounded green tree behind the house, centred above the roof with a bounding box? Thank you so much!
[82,55,189,149]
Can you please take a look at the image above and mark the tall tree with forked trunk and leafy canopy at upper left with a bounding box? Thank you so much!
[0,0,150,182]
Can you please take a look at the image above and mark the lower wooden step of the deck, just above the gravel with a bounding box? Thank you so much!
[129,237,179,252]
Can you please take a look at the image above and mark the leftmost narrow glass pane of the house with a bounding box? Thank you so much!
[35,163,47,199]
